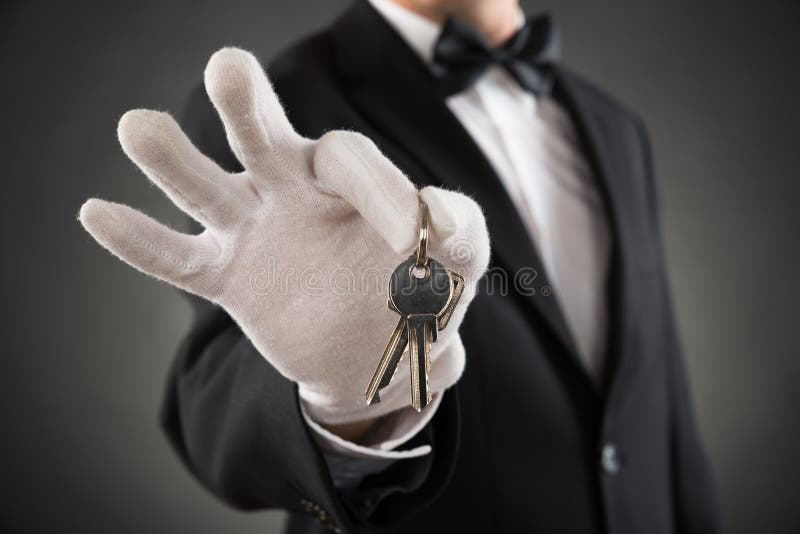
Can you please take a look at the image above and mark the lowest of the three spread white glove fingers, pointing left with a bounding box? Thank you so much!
[79,198,221,296]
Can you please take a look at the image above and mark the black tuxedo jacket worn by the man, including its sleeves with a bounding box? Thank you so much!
[162,1,718,534]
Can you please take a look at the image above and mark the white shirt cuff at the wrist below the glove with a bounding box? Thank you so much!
[300,393,442,460]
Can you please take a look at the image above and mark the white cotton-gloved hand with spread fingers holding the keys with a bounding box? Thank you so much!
[80,48,489,424]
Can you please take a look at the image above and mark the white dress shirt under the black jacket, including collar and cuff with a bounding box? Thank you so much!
[312,0,610,458]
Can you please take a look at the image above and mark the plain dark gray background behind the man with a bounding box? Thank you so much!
[0,0,800,533]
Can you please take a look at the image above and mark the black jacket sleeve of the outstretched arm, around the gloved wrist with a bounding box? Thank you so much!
[161,84,458,532]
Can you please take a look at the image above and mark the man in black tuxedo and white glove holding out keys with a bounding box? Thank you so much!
[81,0,718,533]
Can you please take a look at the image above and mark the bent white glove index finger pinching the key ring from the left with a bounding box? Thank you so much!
[314,130,419,254]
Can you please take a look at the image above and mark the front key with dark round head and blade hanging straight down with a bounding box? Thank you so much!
[389,256,453,412]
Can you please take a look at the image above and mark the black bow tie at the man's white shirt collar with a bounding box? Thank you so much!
[431,15,559,98]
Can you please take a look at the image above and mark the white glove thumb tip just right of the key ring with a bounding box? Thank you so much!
[420,187,490,282]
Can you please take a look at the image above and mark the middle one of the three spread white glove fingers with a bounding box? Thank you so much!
[117,109,241,228]
